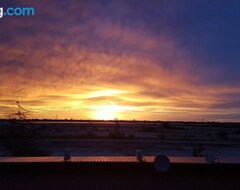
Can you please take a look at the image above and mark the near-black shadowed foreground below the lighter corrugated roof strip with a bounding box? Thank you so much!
[0,162,240,190]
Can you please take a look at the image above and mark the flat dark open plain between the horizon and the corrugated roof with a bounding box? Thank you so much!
[0,120,240,157]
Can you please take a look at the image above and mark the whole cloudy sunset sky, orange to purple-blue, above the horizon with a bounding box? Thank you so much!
[0,0,240,121]
